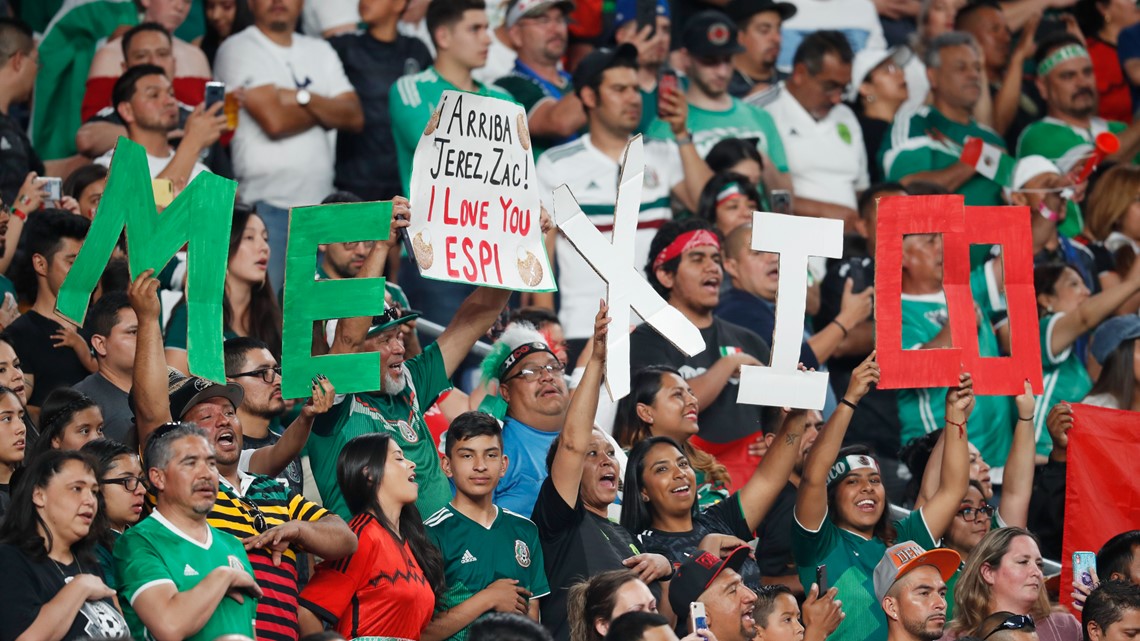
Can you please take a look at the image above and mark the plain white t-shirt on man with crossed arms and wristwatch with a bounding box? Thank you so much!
[214,26,352,208]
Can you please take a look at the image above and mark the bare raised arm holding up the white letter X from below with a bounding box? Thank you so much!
[551,301,610,506]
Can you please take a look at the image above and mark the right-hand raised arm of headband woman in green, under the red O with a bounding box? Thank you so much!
[921,374,974,541]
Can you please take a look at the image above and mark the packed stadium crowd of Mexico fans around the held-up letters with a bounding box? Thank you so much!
[0,0,1140,641]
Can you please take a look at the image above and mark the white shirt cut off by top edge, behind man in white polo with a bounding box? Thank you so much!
[776,0,887,73]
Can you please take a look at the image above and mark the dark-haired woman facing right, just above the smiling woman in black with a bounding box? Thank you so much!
[613,365,732,510]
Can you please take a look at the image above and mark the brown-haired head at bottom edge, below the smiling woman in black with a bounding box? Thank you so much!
[567,569,657,641]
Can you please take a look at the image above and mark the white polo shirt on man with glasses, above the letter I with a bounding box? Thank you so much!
[767,87,870,209]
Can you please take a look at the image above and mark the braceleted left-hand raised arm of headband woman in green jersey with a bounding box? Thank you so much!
[796,351,879,530]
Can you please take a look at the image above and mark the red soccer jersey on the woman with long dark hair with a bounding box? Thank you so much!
[301,513,435,639]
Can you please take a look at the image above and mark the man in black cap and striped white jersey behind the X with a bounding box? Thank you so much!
[535,44,711,355]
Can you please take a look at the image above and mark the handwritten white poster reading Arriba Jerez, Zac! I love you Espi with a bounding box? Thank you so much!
[408,91,555,292]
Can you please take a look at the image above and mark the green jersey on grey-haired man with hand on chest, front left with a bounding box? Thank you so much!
[114,510,258,641]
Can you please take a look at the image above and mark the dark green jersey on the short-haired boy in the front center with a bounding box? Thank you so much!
[424,505,551,641]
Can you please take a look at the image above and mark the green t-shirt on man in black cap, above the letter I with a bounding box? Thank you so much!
[642,98,788,172]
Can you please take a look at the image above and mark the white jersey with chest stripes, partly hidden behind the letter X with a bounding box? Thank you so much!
[535,133,685,339]
